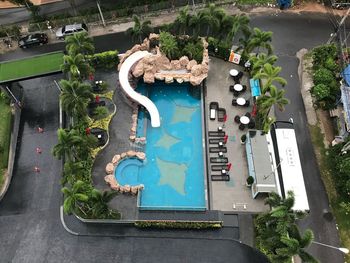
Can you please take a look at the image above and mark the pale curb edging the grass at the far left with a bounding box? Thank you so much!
[0,93,23,202]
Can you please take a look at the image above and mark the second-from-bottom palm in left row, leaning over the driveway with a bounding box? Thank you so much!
[52,129,84,160]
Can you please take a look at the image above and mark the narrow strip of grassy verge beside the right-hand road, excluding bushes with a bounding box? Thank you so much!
[309,126,350,262]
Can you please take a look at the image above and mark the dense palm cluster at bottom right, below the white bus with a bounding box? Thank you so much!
[254,192,318,263]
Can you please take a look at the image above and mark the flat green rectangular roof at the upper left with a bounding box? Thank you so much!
[0,51,63,82]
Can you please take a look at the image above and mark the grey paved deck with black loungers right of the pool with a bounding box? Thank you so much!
[205,57,269,213]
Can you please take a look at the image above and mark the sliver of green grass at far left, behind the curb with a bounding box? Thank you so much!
[0,97,12,190]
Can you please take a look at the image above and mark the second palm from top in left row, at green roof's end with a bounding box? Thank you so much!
[61,54,93,79]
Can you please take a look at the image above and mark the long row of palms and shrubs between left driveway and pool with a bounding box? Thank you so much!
[52,31,120,219]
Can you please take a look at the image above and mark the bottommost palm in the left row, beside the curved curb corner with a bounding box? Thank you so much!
[62,180,91,215]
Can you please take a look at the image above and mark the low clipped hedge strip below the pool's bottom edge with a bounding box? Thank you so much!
[135,220,222,229]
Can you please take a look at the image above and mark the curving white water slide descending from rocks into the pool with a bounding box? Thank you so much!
[119,51,160,127]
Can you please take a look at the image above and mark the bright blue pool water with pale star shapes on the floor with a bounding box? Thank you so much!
[116,83,206,210]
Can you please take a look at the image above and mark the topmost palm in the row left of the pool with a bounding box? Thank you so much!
[65,32,95,56]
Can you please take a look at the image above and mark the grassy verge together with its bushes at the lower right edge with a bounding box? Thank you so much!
[309,126,350,262]
